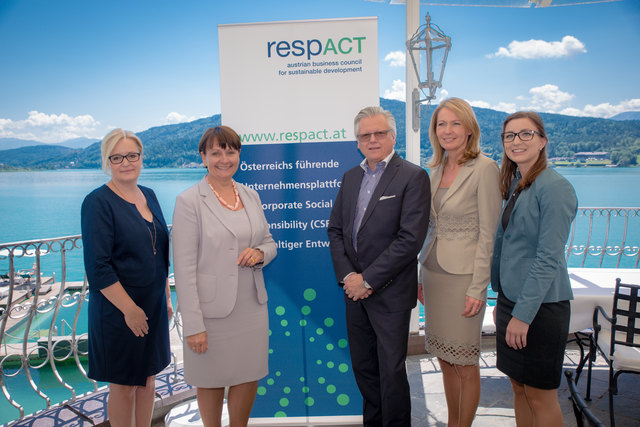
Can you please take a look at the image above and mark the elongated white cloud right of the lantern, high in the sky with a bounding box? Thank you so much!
[487,36,587,59]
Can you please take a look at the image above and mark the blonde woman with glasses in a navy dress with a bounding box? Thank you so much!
[81,129,173,427]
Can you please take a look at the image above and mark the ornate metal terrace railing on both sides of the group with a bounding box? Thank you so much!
[0,208,640,420]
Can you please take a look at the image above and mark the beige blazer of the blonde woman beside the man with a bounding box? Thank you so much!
[419,154,502,300]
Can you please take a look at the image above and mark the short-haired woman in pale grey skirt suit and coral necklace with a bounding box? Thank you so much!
[172,126,276,426]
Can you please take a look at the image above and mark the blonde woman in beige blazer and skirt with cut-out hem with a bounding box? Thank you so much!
[418,98,502,426]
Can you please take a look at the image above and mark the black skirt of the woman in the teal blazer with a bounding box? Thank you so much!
[496,293,571,390]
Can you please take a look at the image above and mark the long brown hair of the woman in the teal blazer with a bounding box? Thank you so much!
[500,111,547,200]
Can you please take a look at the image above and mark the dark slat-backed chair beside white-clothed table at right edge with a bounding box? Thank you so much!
[588,279,640,427]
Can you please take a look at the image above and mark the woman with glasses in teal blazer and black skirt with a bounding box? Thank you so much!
[491,111,578,426]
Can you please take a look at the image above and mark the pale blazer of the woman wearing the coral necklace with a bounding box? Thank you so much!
[171,178,276,336]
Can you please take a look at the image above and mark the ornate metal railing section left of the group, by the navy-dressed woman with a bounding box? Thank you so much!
[0,235,182,424]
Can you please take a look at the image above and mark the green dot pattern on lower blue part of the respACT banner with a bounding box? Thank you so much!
[257,288,358,417]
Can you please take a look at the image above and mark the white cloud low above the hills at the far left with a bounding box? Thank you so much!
[0,110,100,143]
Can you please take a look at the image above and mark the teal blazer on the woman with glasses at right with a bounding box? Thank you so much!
[491,169,578,324]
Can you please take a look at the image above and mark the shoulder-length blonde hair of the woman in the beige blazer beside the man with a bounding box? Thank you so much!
[428,98,480,167]
